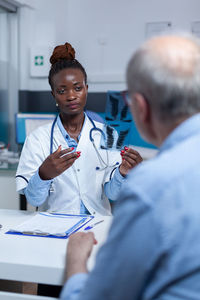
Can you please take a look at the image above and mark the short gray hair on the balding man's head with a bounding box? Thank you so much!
[127,34,200,121]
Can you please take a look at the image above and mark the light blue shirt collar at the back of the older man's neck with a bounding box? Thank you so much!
[159,113,200,152]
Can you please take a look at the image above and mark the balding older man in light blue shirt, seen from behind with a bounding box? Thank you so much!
[61,35,200,300]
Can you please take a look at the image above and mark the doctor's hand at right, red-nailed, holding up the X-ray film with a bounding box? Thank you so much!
[119,146,143,176]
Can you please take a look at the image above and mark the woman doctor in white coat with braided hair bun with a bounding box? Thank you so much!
[16,43,142,215]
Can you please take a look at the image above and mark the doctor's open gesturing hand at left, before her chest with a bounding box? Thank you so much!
[39,146,81,180]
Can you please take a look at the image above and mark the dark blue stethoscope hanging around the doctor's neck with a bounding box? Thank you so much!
[50,116,119,171]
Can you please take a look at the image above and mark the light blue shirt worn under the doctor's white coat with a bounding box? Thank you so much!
[24,116,125,214]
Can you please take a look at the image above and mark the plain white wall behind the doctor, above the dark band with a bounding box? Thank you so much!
[17,0,200,91]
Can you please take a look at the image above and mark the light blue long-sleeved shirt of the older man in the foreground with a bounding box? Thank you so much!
[61,114,200,300]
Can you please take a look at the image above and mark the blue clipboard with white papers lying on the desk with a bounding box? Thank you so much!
[6,212,94,238]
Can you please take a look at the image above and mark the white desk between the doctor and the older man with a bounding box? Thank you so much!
[0,209,112,285]
